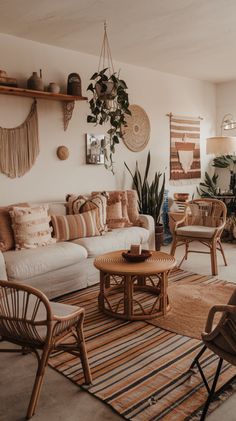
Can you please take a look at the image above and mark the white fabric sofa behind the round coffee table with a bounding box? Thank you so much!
[0,202,155,298]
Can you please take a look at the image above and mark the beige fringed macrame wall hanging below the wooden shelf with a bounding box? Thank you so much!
[0,101,39,178]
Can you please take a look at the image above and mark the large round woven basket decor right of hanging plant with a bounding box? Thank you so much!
[123,105,151,152]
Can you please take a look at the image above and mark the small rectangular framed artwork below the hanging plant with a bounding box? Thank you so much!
[86,133,106,165]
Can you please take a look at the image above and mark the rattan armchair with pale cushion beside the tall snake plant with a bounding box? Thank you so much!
[171,199,227,275]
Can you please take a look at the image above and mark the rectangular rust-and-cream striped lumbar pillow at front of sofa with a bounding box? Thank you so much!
[51,210,100,241]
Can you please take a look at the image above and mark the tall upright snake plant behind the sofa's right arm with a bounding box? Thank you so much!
[124,151,165,225]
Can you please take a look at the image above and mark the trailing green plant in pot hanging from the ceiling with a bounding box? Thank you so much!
[87,67,131,174]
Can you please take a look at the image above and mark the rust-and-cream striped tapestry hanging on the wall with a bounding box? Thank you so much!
[169,114,201,184]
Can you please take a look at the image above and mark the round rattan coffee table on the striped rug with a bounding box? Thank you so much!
[94,250,176,320]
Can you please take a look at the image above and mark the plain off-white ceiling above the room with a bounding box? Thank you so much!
[0,0,236,82]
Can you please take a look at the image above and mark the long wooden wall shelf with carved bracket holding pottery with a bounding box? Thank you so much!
[0,86,88,130]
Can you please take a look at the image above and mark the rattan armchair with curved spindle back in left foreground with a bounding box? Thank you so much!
[0,281,92,419]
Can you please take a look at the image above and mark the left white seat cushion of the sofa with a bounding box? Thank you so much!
[4,242,88,282]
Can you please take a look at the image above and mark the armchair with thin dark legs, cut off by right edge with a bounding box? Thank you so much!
[190,291,236,421]
